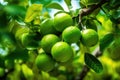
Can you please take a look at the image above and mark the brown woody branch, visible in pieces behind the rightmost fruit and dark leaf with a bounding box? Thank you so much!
[75,0,109,80]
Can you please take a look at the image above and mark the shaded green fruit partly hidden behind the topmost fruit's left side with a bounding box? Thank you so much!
[40,18,57,35]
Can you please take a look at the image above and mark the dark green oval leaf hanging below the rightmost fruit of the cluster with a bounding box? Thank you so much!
[84,53,103,73]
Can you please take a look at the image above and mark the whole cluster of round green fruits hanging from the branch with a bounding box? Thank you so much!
[16,13,98,71]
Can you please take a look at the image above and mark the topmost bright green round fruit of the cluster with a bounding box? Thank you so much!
[54,13,73,32]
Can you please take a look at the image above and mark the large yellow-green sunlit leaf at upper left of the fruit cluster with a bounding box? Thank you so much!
[25,4,42,23]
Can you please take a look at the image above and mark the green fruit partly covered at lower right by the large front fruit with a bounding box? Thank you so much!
[40,34,60,53]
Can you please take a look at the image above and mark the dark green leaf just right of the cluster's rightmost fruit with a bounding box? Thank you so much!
[100,33,114,52]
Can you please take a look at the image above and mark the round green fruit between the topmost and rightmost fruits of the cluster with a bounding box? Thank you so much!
[62,26,81,43]
